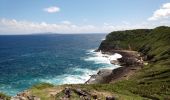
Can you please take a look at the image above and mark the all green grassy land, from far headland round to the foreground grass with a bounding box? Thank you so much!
[2,27,170,100]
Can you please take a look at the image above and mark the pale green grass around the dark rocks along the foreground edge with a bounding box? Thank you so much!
[30,81,146,100]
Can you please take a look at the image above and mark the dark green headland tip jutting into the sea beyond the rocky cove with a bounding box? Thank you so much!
[98,29,152,51]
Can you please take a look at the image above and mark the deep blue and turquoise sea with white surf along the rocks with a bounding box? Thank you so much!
[0,34,115,96]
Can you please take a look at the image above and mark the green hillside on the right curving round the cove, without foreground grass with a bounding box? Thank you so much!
[99,26,170,99]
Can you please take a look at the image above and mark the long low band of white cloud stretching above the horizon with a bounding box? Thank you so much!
[0,19,170,34]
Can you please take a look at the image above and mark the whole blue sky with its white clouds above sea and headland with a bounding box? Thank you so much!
[0,0,170,35]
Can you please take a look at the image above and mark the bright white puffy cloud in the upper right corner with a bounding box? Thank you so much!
[148,3,170,20]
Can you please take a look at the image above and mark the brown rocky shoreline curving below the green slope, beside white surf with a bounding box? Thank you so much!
[85,50,144,84]
